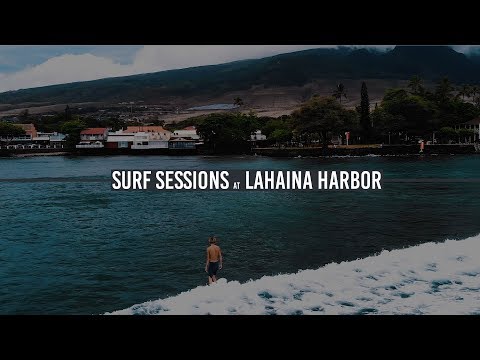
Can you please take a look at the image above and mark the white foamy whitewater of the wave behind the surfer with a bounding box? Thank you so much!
[107,235,480,315]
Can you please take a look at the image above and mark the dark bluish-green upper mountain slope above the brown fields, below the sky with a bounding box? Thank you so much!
[0,46,480,104]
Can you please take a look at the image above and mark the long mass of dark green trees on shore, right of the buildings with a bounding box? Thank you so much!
[175,76,480,152]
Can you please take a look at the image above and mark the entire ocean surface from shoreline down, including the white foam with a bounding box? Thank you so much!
[0,156,480,314]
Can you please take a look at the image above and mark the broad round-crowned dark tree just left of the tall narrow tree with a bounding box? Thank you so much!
[292,97,356,148]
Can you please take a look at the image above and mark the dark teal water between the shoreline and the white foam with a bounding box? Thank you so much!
[0,156,480,314]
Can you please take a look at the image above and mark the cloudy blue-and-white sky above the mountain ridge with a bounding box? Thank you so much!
[0,45,478,91]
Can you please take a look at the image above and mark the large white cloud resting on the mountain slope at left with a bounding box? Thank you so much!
[0,45,348,91]
